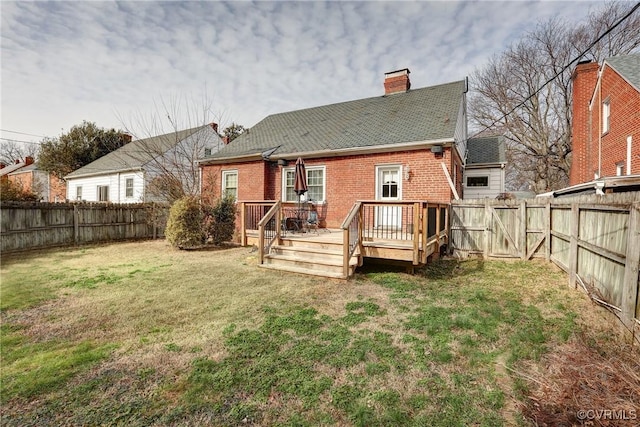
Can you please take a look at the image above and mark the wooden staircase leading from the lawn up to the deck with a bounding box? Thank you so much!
[260,233,362,279]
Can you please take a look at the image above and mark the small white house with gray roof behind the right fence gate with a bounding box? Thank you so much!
[463,136,506,199]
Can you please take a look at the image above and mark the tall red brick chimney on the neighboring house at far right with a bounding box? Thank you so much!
[569,62,599,185]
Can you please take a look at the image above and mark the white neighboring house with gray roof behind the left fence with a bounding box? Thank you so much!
[64,123,224,203]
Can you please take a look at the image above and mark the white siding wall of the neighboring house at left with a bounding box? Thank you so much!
[67,172,144,203]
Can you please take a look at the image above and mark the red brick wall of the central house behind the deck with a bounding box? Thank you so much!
[202,148,462,228]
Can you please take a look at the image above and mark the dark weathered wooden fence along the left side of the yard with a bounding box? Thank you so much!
[0,202,168,253]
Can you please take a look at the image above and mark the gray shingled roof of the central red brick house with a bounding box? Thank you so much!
[203,81,465,162]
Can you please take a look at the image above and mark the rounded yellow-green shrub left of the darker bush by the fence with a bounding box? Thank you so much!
[165,196,205,249]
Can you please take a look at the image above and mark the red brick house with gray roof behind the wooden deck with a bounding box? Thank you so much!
[200,69,467,228]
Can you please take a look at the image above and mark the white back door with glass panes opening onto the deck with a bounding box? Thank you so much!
[376,166,402,229]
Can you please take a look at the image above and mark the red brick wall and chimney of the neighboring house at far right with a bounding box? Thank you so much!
[569,60,640,185]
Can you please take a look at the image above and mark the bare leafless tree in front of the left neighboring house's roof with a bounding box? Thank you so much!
[120,96,229,203]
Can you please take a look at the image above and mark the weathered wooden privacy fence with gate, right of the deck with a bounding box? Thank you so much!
[450,193,640,327]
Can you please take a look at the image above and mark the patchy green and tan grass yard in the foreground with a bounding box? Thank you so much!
[0,241,640,426]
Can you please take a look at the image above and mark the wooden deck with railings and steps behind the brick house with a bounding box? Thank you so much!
[241,201,448,279]
